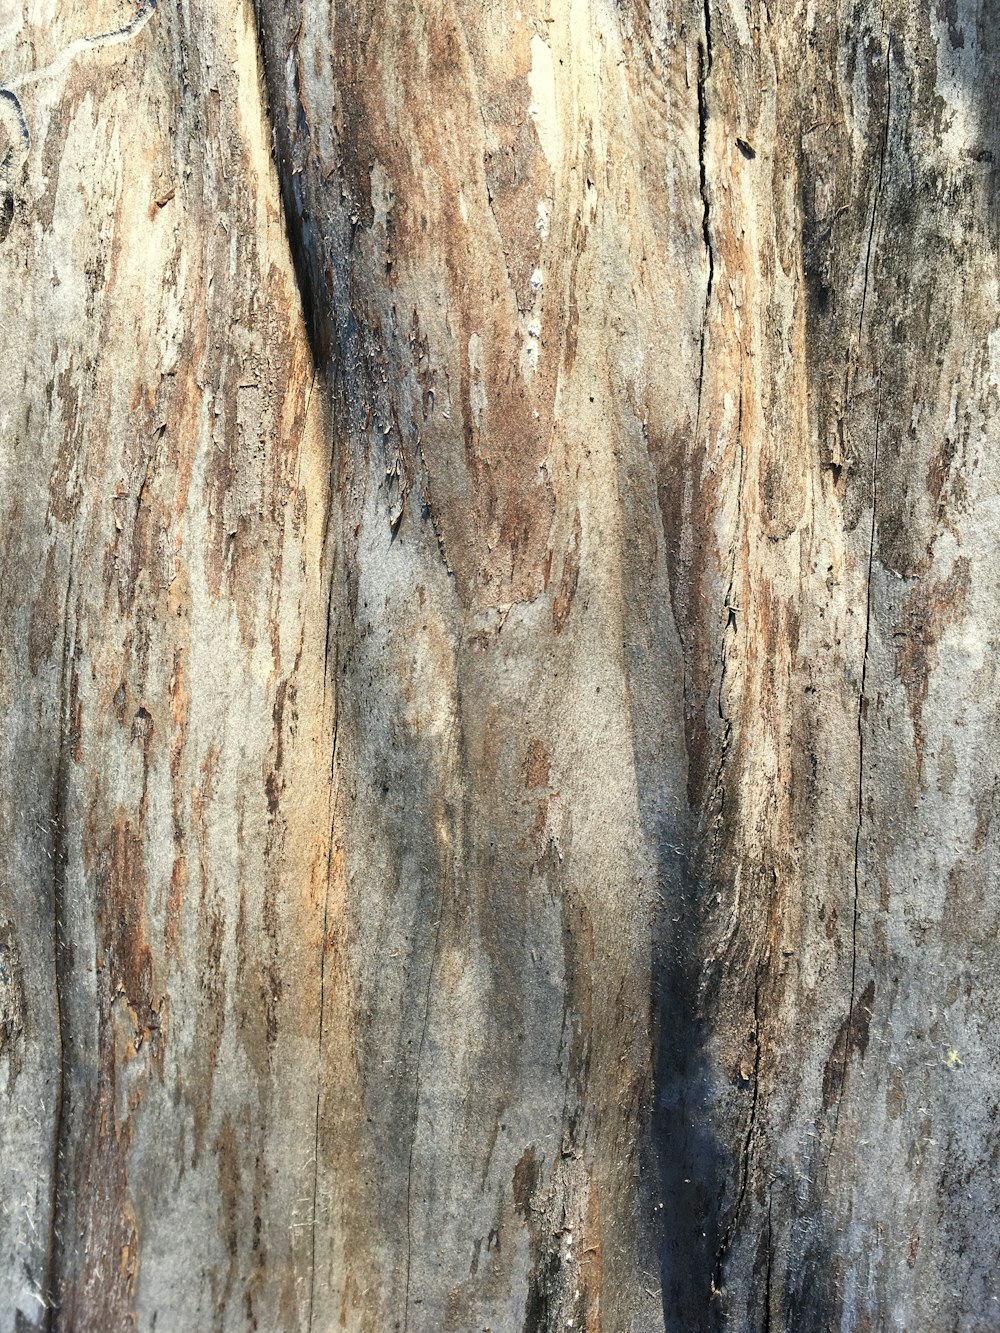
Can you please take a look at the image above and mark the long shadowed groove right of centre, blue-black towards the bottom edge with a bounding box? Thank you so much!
[619,442,739,1333]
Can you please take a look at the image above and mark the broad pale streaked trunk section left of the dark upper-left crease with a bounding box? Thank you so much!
[0,3,332,1333]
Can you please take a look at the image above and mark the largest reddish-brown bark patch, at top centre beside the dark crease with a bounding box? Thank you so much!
[278,3,565,607]
